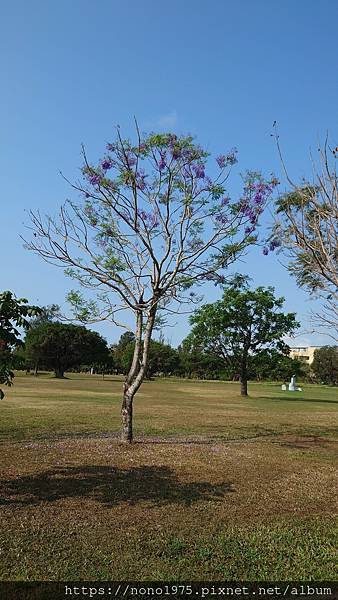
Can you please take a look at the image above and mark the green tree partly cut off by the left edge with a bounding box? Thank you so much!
[0,291,41,398]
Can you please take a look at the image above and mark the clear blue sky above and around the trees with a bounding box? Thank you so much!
[0,0,338,345]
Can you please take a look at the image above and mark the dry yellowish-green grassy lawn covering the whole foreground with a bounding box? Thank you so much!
[0,375,338,581]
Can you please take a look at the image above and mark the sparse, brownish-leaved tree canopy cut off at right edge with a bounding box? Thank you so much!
[271,142,338,340]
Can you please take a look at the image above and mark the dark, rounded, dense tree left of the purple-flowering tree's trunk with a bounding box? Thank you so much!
[25,322,109,378]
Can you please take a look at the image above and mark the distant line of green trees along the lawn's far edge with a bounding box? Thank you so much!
[0,290,338,394]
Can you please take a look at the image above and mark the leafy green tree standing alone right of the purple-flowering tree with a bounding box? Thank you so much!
[189,276,299,396]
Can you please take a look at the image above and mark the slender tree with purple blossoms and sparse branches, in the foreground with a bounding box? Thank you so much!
[28,128,276,442]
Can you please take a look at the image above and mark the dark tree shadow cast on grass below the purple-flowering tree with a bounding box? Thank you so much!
[0,466,234,506]
